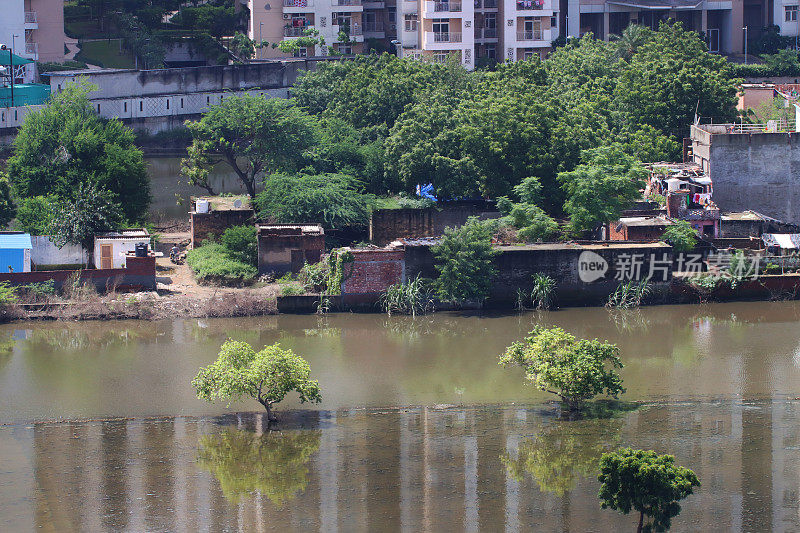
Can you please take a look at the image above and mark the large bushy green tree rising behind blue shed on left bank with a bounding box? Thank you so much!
[7,79,150,222]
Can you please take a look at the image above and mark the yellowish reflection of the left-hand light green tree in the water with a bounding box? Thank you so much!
[197,429,320,505]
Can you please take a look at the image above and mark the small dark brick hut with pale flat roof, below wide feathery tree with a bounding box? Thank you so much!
[258,224,325,274]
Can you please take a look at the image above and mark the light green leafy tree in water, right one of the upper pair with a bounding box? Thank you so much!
[500,326,625,411]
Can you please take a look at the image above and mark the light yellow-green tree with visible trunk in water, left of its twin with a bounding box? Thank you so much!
[192,340,322,422]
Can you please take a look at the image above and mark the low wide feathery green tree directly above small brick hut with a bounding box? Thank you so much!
[255,173,372,228]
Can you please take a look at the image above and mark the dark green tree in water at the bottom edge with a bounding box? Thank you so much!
[598,448,700,533]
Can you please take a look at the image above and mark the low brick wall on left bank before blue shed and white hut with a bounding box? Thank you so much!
[0,256,156,291]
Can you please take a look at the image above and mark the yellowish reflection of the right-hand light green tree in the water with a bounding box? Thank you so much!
[500,418,623,496]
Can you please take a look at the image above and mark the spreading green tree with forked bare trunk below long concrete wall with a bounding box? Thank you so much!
[181,94,317,197]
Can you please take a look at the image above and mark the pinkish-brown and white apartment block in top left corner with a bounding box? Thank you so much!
[0,0,65,61]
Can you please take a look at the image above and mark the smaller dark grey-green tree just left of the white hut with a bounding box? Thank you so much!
[49,183,123,257]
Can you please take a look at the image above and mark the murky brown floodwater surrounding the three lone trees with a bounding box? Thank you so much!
[0,302,800,531]
